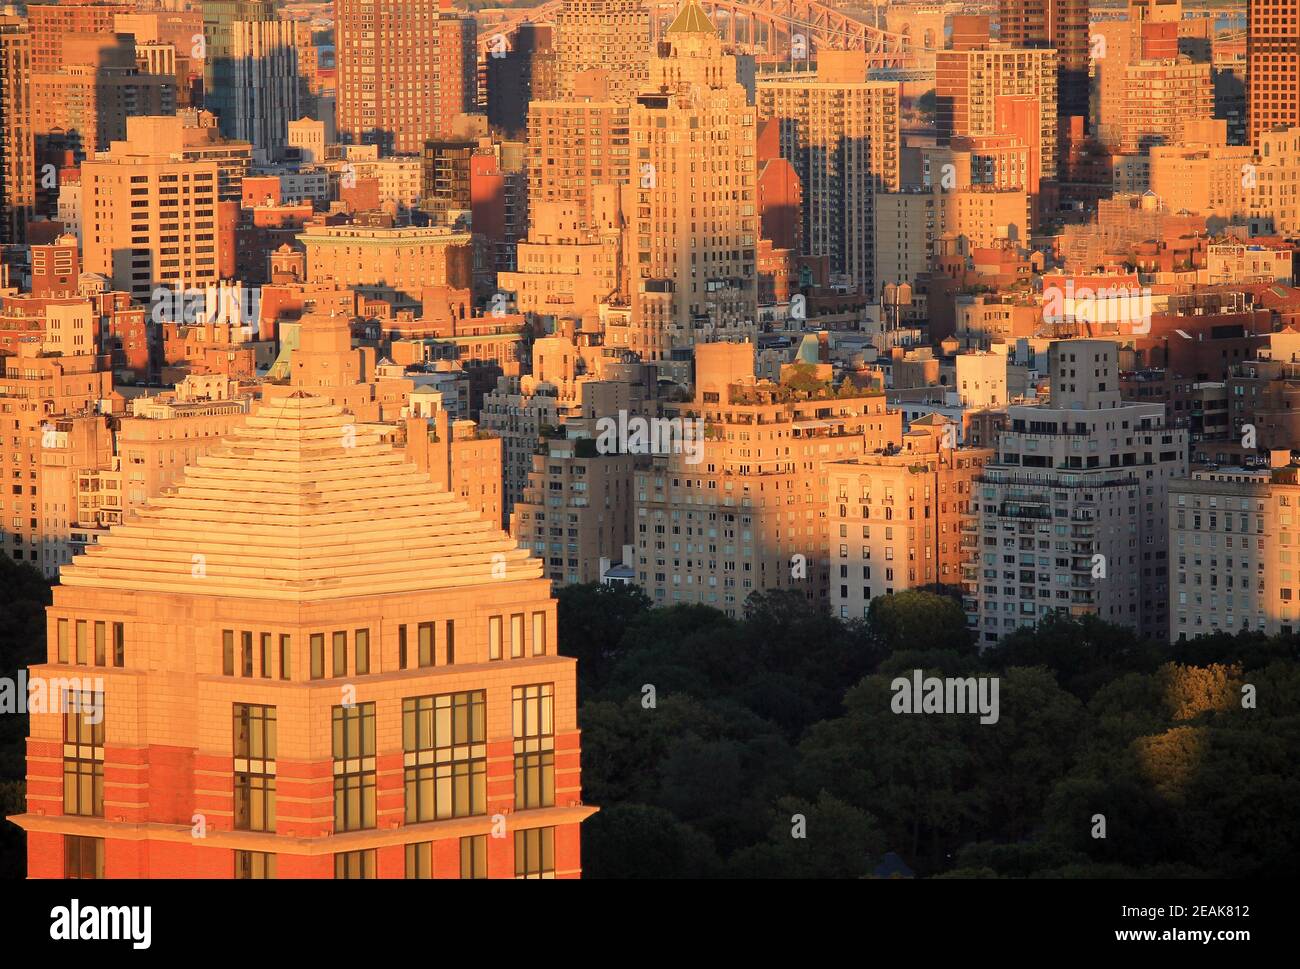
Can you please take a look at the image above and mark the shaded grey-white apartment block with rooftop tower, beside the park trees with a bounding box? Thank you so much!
[967,339,1187,643]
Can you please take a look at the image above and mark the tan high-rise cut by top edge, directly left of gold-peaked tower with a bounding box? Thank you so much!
[551,0,651,103]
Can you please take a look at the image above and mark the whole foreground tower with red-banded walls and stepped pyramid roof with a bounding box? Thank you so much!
[12,392,595,878]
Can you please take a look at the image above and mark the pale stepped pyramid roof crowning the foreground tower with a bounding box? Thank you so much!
[61,392,542,602]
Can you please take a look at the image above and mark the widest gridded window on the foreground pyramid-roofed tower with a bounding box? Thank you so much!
[402,689,488,823]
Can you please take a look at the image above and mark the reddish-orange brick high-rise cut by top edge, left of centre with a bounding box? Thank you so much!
[335,0,478,155]
